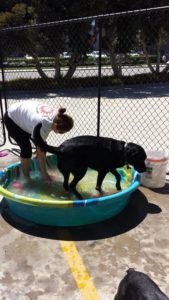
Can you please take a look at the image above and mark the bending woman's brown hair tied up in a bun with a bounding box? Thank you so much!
[53,107,74,132]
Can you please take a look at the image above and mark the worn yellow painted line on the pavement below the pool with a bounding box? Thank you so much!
[57,232,100,300]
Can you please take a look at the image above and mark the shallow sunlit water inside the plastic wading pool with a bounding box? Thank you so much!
[7,168,132,200]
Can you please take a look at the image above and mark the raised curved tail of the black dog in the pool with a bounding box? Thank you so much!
[33,123,60,154]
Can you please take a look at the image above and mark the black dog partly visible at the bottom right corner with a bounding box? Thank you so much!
[114,268,169,300]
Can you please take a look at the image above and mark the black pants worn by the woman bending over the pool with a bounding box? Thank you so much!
[4,112,32,158]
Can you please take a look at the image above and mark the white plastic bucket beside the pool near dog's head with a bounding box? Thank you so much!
[141,150,168,188]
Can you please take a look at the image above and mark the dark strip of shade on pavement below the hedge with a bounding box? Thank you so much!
[8,83,169,100]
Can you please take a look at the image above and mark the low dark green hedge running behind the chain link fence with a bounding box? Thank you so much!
[5,73,169,91]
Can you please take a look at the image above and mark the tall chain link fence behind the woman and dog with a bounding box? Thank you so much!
[0,7,169,169]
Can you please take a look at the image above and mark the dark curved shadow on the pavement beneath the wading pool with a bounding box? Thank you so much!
[1,190,161,241]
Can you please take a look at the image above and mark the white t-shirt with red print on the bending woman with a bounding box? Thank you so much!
[8,100,57,141]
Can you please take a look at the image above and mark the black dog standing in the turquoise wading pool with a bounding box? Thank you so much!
[33,124,146,199]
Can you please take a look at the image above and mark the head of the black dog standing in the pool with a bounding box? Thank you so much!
[124,143,147,173]
